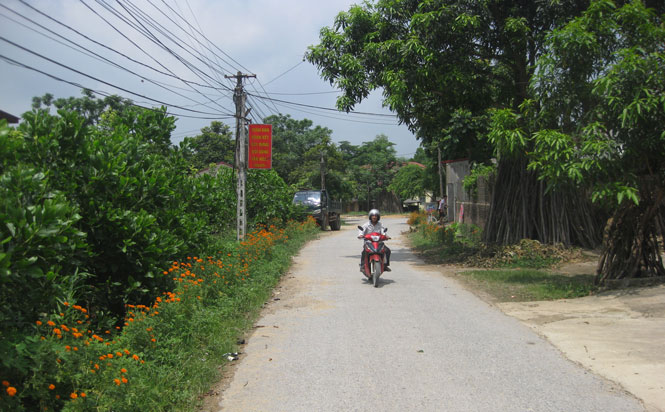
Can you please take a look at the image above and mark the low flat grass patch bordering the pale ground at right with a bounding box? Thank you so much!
[459,269,596,302]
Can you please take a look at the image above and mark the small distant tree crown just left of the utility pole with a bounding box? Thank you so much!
[180,121,235,170]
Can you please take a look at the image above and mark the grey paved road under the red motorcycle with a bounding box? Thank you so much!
[208,218,644,412]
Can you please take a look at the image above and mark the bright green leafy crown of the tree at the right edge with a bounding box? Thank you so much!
[528,1,665,204]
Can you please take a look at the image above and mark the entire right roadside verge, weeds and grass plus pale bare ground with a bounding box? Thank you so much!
[402,215,665,412]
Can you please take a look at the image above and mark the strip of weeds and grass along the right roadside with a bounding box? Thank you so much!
[408,212,597,302]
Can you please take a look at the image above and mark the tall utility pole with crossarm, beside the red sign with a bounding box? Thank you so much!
[224,72,256,241]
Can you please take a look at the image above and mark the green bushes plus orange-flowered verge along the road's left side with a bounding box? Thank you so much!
[0,102,317,411]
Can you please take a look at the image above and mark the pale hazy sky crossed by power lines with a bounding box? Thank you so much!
[0,0,419,157]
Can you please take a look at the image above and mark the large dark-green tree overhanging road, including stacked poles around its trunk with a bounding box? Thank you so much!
[306,0,599,245]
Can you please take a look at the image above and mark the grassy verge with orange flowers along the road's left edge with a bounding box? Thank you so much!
[0,219,319,411]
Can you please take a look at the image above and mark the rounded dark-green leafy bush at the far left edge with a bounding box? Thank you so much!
[0,165,87,326]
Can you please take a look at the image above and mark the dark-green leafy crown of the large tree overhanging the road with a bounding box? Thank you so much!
[306,0,587,161]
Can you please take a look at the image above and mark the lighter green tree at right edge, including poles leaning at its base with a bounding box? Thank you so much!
[520,0,665,281]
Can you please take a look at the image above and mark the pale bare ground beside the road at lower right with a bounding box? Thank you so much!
[439,261,665,412]
